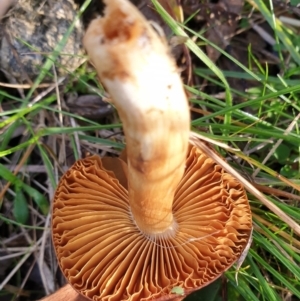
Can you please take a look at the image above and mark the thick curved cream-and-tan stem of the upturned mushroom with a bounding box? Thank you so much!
[84,0,190,238]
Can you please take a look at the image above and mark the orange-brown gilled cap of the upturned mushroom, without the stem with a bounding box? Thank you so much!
[52,145,252,301]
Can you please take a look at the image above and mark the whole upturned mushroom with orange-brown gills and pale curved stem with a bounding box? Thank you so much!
[52,0,252,301]
